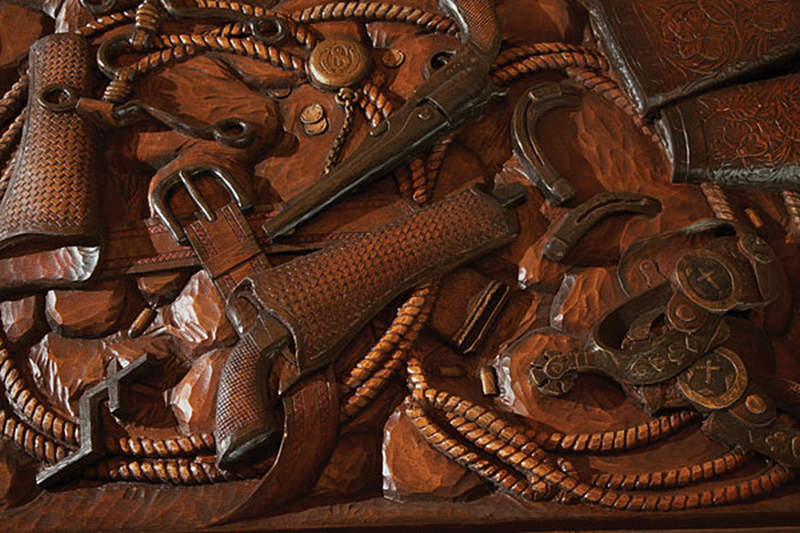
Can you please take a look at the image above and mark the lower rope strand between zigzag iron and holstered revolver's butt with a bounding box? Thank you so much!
[83,456,248,485]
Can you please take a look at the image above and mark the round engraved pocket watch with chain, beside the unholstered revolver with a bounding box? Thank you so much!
[308,39,370,90]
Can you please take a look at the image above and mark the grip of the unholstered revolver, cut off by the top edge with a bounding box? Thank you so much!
[439,0,501,61]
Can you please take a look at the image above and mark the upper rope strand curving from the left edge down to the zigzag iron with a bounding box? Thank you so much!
[0,348,81,446]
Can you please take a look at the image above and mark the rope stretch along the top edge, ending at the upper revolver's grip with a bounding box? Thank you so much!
[291,2,458,35]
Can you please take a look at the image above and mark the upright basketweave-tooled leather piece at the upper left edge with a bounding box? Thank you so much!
[0,33,100,254]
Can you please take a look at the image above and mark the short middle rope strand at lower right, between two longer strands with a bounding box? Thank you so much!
[591,448,748,490]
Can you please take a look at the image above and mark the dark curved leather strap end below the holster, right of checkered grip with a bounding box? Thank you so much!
[210,367,339,525]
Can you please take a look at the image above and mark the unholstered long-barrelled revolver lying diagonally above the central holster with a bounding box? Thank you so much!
[264,0,500,238]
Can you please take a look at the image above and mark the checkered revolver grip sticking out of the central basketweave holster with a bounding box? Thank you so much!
[214,335,281,469]
